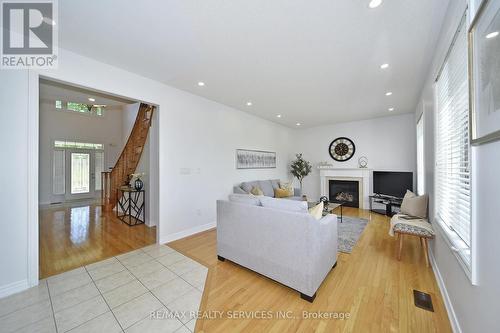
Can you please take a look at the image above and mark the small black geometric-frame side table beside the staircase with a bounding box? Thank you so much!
[116,187,146,227]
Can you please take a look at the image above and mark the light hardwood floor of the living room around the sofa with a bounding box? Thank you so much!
[168,208,451,332]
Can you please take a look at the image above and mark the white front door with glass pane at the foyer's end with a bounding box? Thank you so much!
[66,149,96,200]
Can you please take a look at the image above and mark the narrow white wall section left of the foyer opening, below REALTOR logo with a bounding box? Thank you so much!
[0,70,29,297]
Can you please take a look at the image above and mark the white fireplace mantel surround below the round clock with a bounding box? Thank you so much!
[319,168,373,209]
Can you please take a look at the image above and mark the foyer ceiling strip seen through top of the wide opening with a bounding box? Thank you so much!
[39,79,135,106]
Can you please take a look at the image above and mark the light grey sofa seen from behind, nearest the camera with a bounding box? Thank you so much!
[217,197,337,302]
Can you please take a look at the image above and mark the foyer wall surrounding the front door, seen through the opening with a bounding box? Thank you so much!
[39,101,123,204]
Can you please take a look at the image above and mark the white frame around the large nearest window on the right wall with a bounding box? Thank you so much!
[434,12,477,285]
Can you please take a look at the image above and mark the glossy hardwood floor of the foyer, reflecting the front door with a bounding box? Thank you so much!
[39,205,156,279]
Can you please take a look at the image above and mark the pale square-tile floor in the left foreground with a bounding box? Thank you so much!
[0,245,208,333]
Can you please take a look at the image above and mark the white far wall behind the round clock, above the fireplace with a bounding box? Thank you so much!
[294,114,417,199]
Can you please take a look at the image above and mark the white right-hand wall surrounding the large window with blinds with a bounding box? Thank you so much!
[416,0,500,332]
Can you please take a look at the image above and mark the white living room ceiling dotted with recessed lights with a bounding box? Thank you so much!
[58,0,449,127]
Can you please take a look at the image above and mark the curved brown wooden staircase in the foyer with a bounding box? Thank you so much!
[101,103,154,210]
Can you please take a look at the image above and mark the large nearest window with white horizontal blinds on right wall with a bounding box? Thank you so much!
[436,16,472,272]
